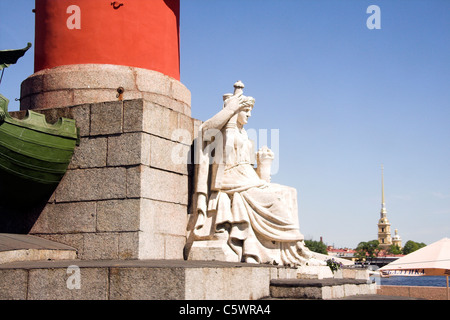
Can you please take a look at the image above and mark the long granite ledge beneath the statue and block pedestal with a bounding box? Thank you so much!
[0,260,295,300]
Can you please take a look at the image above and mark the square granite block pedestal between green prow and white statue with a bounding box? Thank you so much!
[8,99,200,260]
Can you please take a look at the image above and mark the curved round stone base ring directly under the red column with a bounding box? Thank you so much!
[21,64,191,116]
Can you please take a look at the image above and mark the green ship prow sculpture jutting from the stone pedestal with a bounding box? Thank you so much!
[0,94,79,201]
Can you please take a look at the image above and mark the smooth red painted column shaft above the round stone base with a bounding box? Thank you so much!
[34,0,180,80]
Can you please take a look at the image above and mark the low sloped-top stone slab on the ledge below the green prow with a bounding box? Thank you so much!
[0,233,77,264]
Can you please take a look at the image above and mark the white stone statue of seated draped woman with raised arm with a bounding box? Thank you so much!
[188,81,322,265]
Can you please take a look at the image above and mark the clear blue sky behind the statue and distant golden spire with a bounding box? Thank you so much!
[0,0,450,247]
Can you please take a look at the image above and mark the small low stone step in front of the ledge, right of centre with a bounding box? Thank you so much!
[270,278,376,300]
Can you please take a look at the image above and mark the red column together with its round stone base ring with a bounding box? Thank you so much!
[20,0,191,115]
